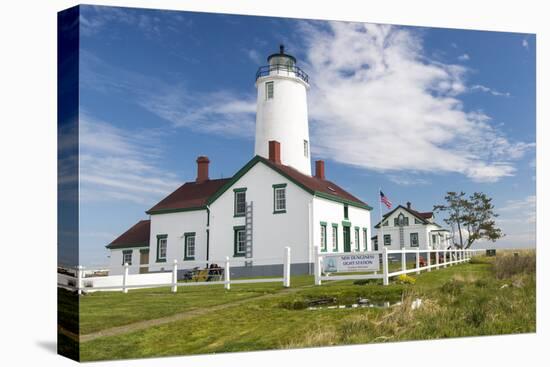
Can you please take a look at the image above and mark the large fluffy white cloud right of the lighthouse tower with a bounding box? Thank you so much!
[302,22,531,182]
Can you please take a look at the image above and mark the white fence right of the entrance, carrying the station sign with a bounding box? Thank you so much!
[314,248,485,285]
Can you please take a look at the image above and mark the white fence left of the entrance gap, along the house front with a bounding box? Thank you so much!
[57,247,291,294]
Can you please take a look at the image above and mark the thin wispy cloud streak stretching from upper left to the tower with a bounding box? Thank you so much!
[81,50,256,138]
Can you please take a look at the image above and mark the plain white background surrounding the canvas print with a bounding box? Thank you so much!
[0,0,550,367]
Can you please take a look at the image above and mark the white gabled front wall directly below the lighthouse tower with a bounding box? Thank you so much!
[210,162,312,265]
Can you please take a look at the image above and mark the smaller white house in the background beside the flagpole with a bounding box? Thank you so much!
[372,202,452,250]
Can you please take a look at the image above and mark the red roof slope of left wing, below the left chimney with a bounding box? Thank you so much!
[147,178,231,214]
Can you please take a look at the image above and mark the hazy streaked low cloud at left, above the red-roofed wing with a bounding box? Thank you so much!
[79,113,181,205]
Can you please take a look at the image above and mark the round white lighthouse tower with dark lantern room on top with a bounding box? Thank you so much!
[255,45,311,175]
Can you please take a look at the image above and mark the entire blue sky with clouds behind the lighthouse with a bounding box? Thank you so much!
[75,6,536,265]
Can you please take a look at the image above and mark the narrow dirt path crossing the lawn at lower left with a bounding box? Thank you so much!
[70,285,313,343]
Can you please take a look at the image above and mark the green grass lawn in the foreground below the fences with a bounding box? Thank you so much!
[75,255,536,361]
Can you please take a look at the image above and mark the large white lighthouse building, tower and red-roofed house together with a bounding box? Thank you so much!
[107,46,372,276]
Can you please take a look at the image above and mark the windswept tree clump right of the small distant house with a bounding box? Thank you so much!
[434,191,504,248]
